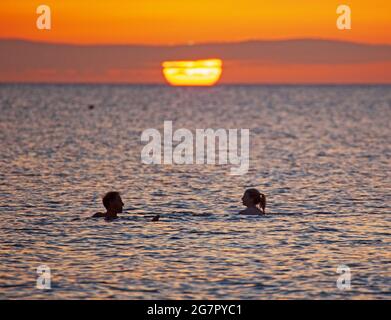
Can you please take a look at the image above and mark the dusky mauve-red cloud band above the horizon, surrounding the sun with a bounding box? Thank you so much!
[0,39,391,83]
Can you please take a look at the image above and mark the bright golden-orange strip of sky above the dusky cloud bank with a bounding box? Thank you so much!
[0,0,391,44]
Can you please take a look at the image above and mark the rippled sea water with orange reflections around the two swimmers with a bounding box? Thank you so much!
[0,85,391,299]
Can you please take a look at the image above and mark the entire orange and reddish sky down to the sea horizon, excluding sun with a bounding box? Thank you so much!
[0,0,391,83]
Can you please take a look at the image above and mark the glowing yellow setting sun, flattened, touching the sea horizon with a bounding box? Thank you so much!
[162,59,223,86]
